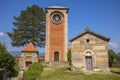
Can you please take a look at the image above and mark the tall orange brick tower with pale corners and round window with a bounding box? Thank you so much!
[45,6,69,62]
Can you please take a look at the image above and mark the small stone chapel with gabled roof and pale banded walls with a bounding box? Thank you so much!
[70,28,110,72]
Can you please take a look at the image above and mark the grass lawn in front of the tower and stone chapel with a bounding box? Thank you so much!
[41,67,120,80]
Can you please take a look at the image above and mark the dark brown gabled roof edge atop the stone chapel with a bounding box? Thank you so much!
[69,30,110,42]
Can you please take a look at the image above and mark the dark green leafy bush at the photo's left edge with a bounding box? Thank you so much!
[0,43,18,76]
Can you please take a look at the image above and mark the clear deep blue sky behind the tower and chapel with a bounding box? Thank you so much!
[0,0,120,53]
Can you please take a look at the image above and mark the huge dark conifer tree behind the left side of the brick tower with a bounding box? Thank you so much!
[7,5,45,47]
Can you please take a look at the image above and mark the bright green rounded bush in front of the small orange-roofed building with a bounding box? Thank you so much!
[23,62,43,80]
